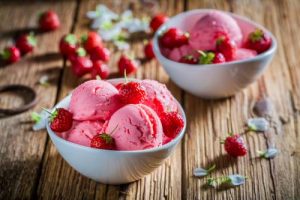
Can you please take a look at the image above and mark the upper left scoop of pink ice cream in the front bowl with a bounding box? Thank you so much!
[69,80,121,121]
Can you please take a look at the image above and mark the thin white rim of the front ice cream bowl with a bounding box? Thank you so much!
[46,78,187,154]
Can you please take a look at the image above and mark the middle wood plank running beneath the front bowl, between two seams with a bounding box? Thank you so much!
[38,1,183,199]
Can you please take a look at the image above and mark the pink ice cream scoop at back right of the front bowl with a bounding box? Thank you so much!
[140,80,178,112]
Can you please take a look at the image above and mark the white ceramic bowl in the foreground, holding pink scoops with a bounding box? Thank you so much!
[47,79,186,184]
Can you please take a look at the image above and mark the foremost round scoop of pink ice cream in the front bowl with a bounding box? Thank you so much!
[106,104,163,150]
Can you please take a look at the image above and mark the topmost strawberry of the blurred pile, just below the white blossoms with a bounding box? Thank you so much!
[81,31,103,53]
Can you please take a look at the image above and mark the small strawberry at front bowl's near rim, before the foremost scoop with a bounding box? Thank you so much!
[90,133,116,150]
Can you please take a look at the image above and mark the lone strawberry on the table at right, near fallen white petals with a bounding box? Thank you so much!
[224,134,247,157]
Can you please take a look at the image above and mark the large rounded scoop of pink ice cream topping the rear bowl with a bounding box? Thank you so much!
[189,11,243,51]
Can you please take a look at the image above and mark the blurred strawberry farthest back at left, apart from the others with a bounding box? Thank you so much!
[39,10,60,31]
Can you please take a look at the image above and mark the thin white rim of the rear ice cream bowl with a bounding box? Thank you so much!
[153,9,277,69]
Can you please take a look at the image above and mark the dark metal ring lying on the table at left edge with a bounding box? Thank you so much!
[0,84,37,116]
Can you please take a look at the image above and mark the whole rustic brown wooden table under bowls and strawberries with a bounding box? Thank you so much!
[0,0,300,200]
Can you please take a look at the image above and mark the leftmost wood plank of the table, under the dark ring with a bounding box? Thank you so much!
[0,1,75,199]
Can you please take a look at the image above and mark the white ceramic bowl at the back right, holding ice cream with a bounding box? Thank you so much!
[153,9,277,98]
